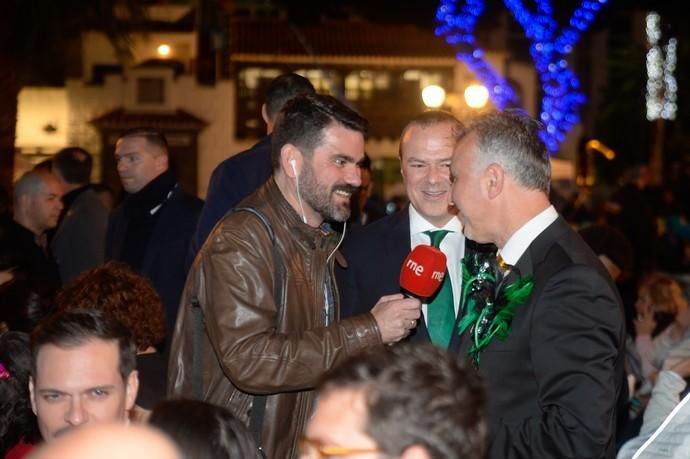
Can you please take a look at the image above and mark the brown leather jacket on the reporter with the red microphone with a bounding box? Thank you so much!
[168,178,381,459]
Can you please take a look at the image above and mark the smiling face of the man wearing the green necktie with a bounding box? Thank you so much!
[400,122,454,227]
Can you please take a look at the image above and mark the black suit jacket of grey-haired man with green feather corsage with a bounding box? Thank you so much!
[460,217,625,459]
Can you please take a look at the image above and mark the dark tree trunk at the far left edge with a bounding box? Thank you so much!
[0,55,21,193]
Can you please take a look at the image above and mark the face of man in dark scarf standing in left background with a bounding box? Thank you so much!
[115,136,168,193]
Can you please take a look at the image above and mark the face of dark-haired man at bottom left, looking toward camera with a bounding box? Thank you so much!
[29,338,139,441]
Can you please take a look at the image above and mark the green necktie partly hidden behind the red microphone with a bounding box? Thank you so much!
[424,230,455,349]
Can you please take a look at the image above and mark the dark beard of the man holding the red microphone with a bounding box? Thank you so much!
[299,162,357,222]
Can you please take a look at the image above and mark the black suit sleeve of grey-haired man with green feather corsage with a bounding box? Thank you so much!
[491,265,623,459]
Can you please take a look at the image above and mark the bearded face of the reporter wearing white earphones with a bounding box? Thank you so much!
[298,123,364,222]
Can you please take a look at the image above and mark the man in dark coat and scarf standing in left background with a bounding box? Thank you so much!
[106,127,203,344]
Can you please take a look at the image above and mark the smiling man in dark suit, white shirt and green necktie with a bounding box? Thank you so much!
[337,111,465,348]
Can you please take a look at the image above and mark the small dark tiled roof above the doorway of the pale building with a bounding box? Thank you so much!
[91,108,208,131]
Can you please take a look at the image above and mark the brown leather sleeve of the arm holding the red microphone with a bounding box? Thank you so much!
[201,221,381,394]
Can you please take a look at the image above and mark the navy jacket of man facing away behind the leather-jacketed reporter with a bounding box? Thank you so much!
[187,136,273,267]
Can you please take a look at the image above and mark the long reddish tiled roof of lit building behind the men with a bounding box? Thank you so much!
[230,18,455,59]
